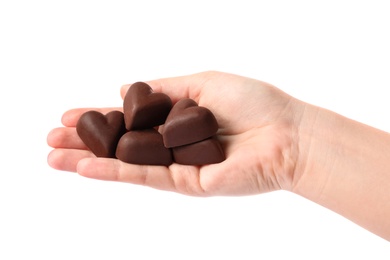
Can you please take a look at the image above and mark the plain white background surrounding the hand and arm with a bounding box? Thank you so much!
[0,0,390,259]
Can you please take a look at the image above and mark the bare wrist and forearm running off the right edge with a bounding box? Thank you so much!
[291,101,390,239]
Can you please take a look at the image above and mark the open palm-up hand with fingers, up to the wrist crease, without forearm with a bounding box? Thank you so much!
[48,72,303,196]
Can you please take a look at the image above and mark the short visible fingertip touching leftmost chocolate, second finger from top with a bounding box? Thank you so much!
[47,127,87,150]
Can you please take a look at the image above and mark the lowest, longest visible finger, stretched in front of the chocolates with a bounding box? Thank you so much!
[77,158,206,196]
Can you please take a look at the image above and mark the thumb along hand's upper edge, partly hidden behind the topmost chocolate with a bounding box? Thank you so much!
[121,72,212,103]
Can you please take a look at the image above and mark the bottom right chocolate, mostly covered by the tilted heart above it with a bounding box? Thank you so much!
[172,137,225,165]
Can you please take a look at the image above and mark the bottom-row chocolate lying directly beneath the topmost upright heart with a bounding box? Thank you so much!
[116,128,172,166]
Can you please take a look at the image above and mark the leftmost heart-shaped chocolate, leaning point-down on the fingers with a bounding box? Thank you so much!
[76,111,126,158]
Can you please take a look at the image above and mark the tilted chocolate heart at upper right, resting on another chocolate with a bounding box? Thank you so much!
[162,98,218,148]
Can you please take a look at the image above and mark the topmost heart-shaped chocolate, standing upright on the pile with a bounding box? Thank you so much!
[123,82,172,130]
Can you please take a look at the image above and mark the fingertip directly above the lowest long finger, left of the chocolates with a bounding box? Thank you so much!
[47,149,95,172]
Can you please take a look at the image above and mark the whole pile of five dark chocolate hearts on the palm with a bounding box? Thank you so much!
[76,82,225,166]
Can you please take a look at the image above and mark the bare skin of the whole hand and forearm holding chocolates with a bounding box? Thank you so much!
[47,71,390,240]
